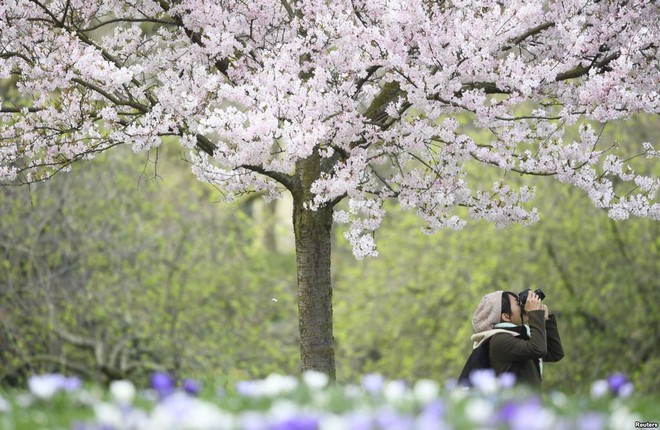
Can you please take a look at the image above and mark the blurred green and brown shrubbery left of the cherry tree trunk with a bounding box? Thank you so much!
[0,148,298,383]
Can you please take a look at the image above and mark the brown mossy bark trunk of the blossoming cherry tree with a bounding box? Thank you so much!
[293,155,336,379]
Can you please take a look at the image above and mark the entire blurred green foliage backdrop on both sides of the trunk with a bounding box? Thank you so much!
[0,117,660,394]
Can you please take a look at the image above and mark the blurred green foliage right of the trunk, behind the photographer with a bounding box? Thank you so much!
[334,113,660,393]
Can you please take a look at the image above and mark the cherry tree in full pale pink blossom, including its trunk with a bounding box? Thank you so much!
[0,0,660,375]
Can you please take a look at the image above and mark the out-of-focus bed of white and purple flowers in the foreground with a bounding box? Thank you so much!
[0,371,657,430]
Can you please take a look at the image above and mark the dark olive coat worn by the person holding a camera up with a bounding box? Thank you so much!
[489,310,564,388]
